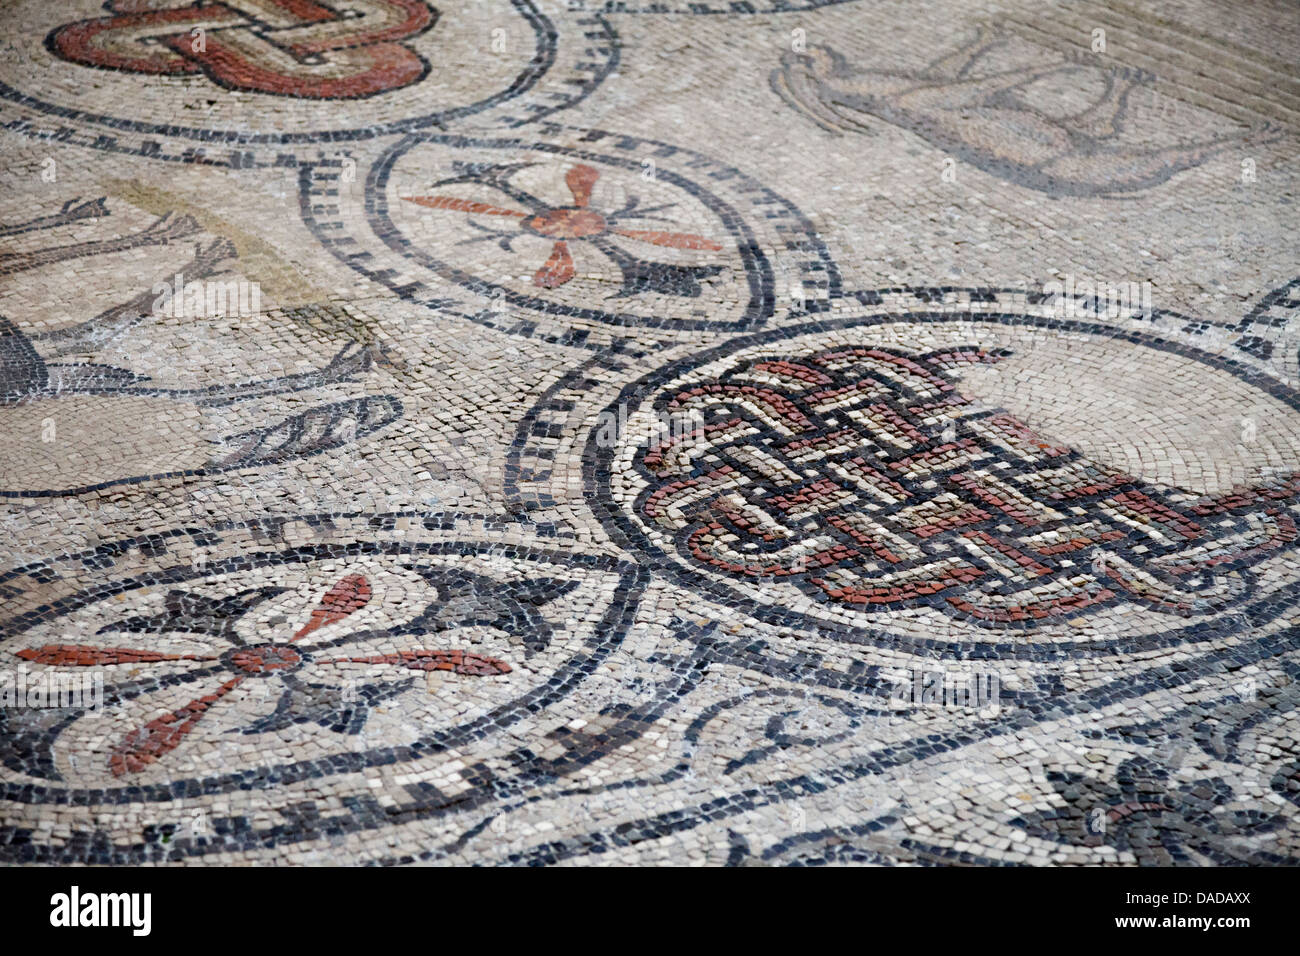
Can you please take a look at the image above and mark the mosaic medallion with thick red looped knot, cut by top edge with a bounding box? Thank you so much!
[0,0,616,166]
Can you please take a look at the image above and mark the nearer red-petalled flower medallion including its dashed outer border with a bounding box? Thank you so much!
[0,515,637,856]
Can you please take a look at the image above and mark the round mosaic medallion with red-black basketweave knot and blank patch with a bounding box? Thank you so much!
[561,306,1300,653]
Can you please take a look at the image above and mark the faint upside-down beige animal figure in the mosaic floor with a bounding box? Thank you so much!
[771,30,1274,196]
